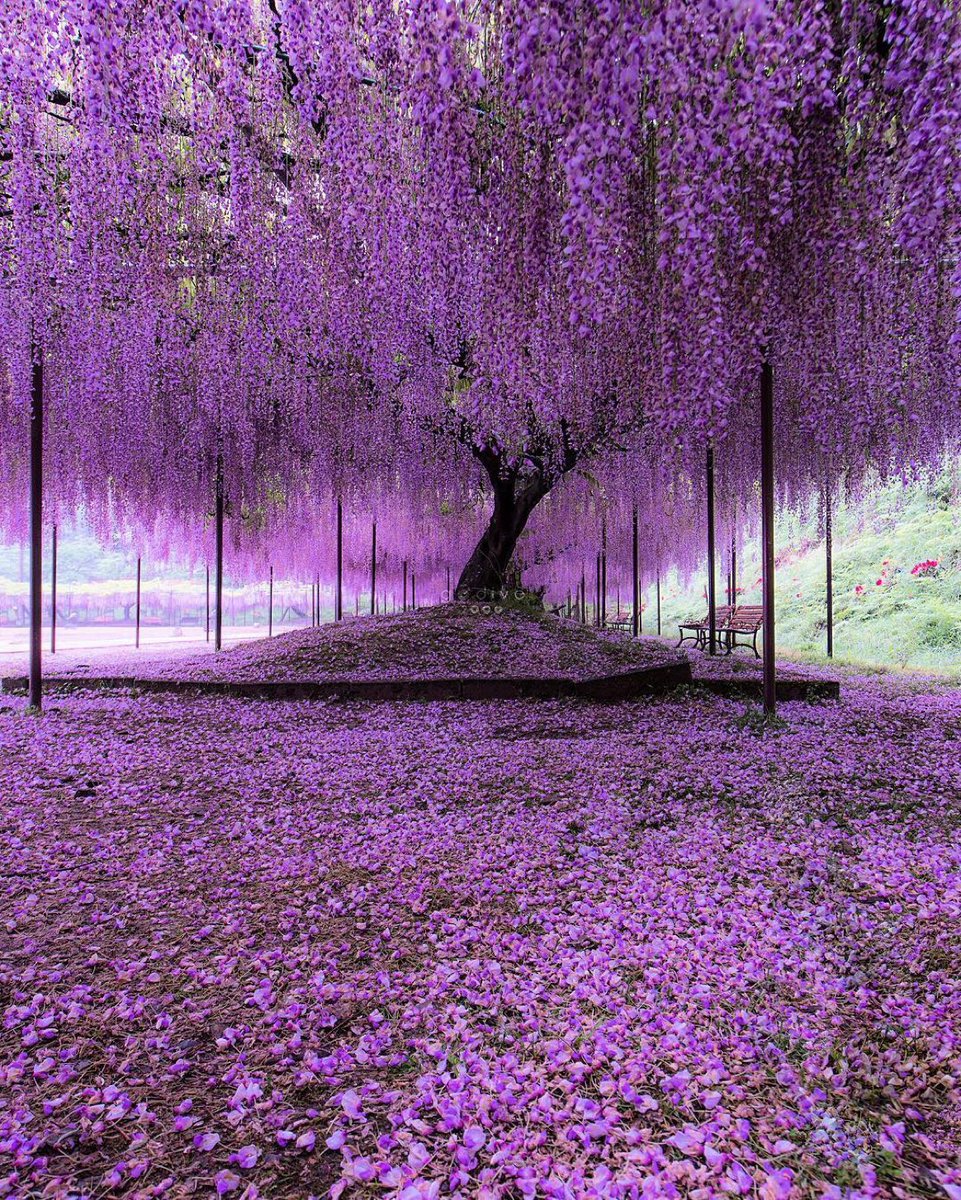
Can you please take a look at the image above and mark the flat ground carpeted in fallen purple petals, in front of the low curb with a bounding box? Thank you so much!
[0,680,961,1200]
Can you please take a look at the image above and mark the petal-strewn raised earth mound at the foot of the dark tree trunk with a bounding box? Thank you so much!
[5,602,690,698]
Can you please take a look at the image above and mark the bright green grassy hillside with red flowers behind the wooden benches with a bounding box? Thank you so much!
[648,474,961,671]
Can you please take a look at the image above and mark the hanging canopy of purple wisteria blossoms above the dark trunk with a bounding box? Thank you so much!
[0,0,961,571]
